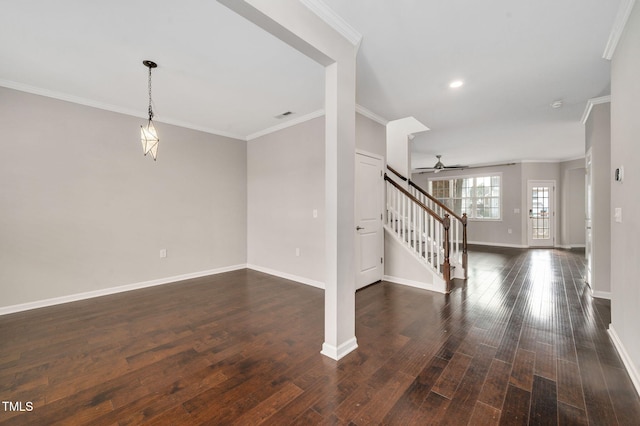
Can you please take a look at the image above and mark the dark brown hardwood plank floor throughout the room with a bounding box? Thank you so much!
[0,247,640,425]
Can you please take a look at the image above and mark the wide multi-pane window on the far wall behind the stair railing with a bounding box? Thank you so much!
[429,175,502,220]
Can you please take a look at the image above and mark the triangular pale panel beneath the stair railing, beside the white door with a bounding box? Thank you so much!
[384,226,447,294]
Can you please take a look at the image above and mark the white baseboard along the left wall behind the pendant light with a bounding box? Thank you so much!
[0,264,247,316]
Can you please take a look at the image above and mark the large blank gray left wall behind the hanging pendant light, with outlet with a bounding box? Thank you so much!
[0,88,246,307]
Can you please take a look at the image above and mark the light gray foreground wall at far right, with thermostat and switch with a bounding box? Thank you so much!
[610,2,640,392]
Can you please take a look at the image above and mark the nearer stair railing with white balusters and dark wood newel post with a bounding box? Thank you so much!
[384,173,451,293]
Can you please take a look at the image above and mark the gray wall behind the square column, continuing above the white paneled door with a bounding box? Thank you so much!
[247,114,386,287]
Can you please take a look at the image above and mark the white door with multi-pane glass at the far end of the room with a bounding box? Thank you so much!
[527,180,556,247]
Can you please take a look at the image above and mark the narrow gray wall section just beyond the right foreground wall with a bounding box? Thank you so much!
[585,103,612,293]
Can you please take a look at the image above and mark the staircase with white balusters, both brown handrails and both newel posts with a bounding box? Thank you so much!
[384,167,467,293]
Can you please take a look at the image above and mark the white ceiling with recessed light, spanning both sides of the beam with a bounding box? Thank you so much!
[0,0,620,167]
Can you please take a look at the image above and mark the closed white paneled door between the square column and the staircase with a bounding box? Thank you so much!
[355,152,384,289]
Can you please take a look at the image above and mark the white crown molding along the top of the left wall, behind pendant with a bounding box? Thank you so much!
[0,79,245,141]
